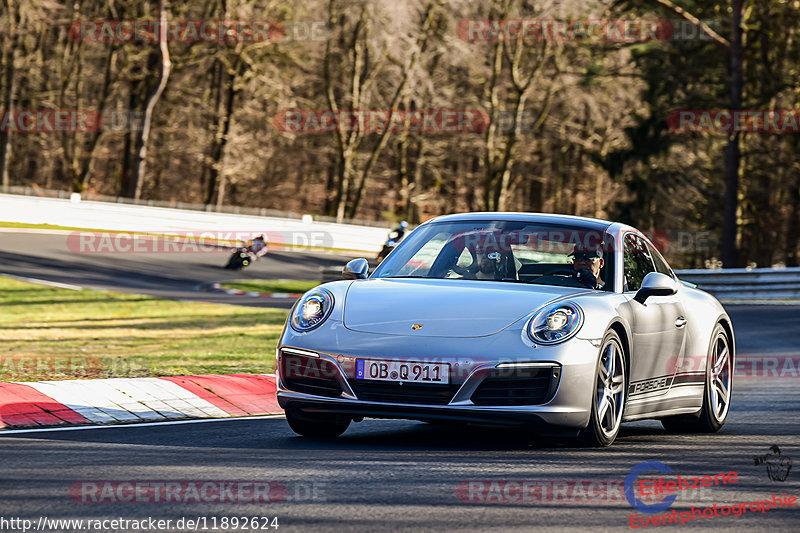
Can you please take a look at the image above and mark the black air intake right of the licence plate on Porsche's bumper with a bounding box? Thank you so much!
[471,366,561,406]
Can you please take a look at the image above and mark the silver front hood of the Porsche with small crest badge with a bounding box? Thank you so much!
[344,278,586,337]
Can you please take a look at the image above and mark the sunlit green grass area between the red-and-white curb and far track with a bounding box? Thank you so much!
[0,277,286,381]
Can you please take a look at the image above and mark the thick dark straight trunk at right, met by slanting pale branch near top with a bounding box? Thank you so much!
[722,0,743,268]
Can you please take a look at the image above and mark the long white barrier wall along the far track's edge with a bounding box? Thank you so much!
[0,194,389,255]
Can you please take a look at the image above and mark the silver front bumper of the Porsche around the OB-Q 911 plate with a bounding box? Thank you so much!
[277,332,598,435]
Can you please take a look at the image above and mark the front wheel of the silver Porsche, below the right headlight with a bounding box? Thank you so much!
[579,330,628,447]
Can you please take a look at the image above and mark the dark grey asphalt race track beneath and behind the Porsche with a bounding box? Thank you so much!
[0,233,800,531]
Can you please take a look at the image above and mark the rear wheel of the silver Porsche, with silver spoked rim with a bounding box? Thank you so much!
[661,324,733,433]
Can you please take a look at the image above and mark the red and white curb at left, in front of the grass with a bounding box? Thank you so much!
[0,374,283,428]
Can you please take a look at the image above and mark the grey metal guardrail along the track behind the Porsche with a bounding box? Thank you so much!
[320,265,800,301]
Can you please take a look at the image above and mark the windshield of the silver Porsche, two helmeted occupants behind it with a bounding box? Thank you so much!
[373,221,613,290]
